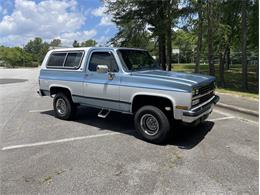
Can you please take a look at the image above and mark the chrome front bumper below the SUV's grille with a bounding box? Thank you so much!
[182,95,219,123]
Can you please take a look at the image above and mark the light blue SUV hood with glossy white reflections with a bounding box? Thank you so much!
[132,70,215,86]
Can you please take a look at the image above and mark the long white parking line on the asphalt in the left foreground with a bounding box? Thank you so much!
[1,132,121,151]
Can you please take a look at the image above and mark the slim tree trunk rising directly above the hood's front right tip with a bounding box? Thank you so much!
[207,0,215,76]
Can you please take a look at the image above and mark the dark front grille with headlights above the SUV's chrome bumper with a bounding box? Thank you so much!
[192,82,215,108]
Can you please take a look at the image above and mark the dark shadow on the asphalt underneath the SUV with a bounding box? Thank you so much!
[41,107,214,149]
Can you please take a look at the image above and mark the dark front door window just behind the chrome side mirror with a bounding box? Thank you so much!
[88,52,118,72]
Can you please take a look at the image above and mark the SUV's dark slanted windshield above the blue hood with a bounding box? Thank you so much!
[117,49,159,71]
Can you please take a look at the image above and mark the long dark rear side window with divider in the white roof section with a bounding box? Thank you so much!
[47,51,84,69]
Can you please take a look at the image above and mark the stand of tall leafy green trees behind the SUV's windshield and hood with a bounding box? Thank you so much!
[104,0,259,91]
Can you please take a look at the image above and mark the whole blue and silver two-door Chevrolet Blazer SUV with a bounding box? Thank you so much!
[38,47,219,143]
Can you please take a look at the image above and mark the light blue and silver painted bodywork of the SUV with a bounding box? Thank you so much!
[39,47,216,123]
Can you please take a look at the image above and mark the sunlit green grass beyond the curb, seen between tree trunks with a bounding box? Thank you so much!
[172,64,259,99]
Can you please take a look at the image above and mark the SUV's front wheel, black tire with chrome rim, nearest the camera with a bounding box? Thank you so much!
[134,106,171,144]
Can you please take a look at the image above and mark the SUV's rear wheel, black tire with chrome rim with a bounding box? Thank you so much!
[53,92,77,120]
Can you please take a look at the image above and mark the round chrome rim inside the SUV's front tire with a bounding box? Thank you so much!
[140,114,159,136]
